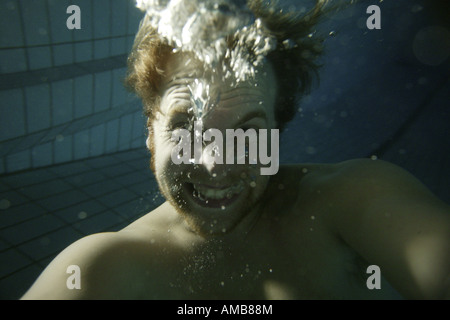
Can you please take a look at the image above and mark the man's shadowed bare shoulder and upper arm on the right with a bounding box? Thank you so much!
[306,160,450,299]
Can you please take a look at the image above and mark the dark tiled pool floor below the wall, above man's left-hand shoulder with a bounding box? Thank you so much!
[0,148,162,299]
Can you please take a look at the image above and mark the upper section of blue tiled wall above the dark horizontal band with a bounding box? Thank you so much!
[0,0,141,69]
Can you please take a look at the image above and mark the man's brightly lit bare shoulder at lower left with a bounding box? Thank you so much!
[22,233,144,300]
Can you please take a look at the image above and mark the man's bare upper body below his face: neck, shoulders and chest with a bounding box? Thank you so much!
[23,160,450,299]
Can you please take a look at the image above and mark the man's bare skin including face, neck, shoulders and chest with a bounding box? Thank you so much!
[23,53,450,299]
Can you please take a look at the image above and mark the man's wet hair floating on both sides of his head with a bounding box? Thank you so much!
[125,0,327,134]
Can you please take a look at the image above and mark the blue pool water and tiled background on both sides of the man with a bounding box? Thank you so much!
[0,0,450,299]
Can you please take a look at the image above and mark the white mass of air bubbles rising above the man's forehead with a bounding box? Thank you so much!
[136,0,276,118]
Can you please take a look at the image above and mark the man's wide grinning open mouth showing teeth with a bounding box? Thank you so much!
[185,181,244,210]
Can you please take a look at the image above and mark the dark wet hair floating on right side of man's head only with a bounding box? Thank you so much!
[249,0,326,130]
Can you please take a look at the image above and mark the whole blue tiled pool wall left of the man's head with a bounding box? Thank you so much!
[0,0,144,174]
